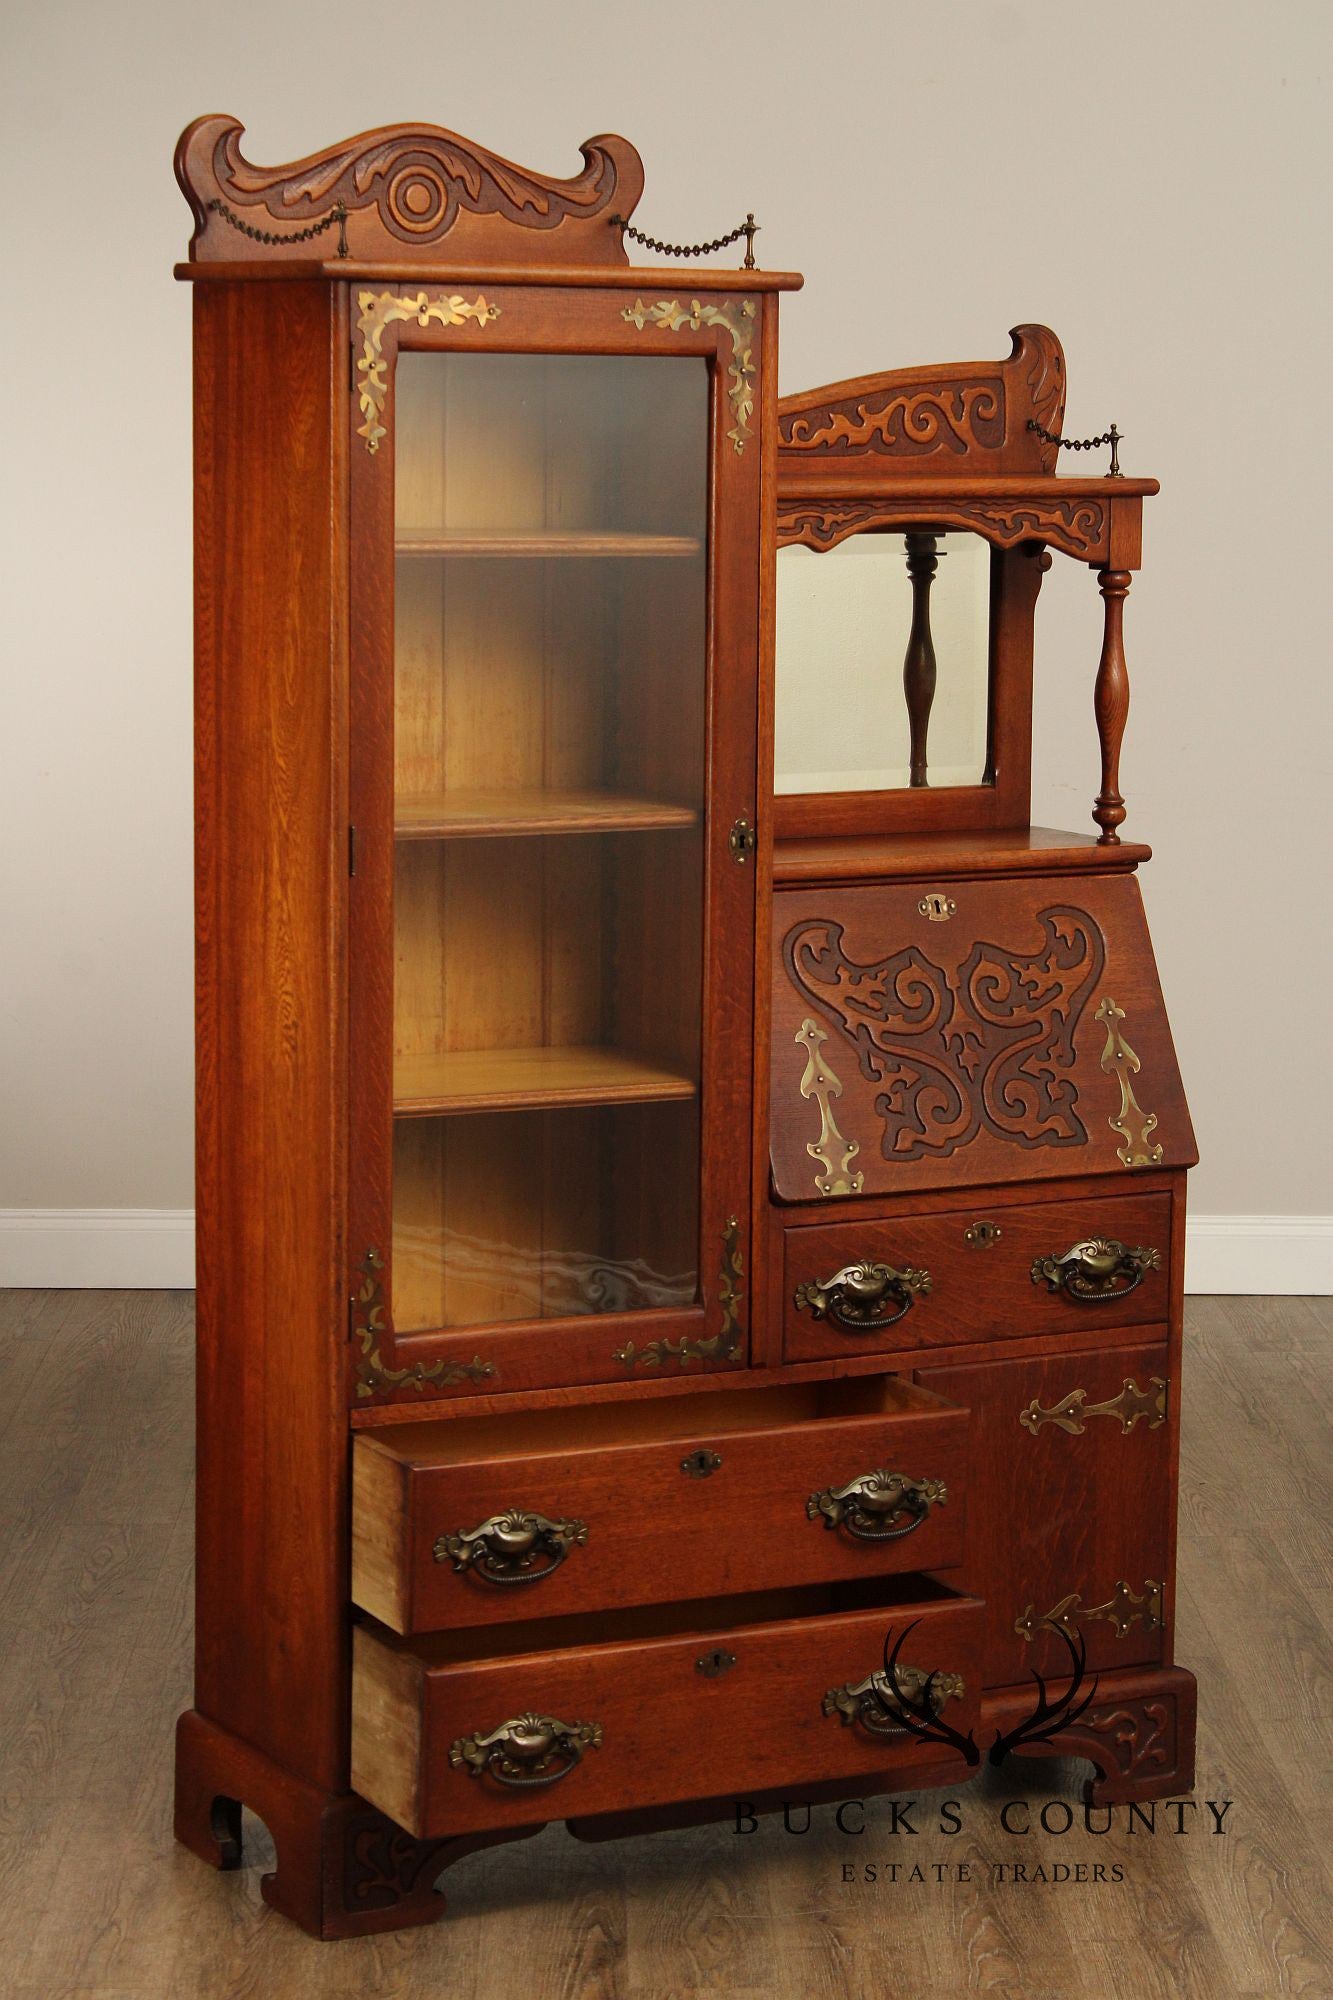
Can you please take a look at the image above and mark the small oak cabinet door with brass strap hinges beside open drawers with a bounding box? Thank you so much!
[912,1336,1173,1686]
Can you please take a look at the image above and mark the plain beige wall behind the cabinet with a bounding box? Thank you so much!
[0,0,1333,1214]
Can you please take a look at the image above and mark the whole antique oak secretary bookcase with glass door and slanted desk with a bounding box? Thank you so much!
[176,116,1195,1936]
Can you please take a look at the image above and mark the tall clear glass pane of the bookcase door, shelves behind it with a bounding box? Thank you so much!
[394,352,709,1332]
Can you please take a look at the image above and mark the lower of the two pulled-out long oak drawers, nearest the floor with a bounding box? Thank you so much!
[352,1578,981,1840]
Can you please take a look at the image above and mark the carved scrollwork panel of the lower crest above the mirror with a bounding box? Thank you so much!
[779,374,1005,458]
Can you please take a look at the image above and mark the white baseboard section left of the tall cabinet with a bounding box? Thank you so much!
[0,1208,194,1292]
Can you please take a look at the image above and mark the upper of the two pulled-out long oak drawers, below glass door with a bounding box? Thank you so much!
[352,1376,967,1632]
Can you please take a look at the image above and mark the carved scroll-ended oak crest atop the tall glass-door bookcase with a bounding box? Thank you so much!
[176,112,642,264]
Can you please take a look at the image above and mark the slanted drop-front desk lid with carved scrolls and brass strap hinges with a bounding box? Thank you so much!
[771,874,1197,1202]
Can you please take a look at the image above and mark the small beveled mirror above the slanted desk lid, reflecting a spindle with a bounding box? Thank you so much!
[775,534,991,792]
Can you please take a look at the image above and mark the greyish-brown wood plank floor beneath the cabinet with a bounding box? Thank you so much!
[0,1292,1333,2000]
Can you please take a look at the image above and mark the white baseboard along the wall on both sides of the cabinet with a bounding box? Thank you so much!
[0,1208,1333,1296]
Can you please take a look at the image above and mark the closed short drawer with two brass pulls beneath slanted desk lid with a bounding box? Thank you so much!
[783,1194,1171,1362]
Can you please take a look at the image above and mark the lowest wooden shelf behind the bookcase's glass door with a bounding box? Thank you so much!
[394,1048,697,1118]
